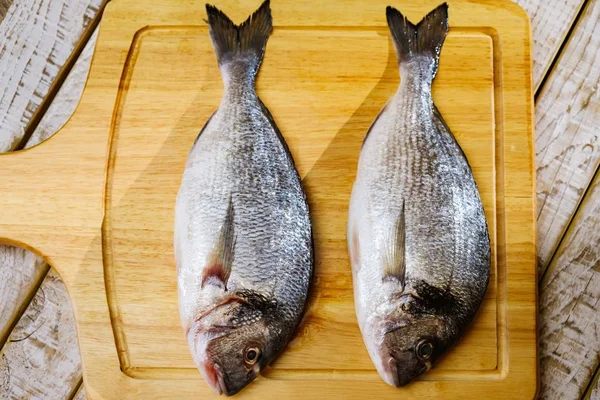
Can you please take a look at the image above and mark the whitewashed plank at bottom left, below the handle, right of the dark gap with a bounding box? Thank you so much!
[0,271,81,399]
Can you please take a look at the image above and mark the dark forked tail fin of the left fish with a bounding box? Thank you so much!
[206,0,273,72]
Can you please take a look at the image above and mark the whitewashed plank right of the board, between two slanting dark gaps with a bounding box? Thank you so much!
[535,0,600,273]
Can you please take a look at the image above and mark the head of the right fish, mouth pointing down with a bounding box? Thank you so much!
[372,296,451,387]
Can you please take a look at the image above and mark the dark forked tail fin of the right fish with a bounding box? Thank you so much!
[386,3,448,76]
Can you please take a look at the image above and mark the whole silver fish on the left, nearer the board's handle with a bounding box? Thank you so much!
[173,0,314,396]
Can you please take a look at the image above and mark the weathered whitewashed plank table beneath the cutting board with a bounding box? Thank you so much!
[0,0,600,399]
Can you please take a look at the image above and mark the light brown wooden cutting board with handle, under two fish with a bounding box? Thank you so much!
[0,0,537,399]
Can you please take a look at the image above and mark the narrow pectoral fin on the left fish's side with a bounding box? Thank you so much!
[201,196,236,290]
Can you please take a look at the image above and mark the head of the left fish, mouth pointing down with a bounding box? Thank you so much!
[188,292,283,396]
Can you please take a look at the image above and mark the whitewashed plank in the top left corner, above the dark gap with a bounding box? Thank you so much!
[0,0,102,152]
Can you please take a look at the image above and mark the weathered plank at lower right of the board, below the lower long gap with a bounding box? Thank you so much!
[540,170,600,399]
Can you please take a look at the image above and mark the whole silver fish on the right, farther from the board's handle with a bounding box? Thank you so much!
[346,3,490,387]
